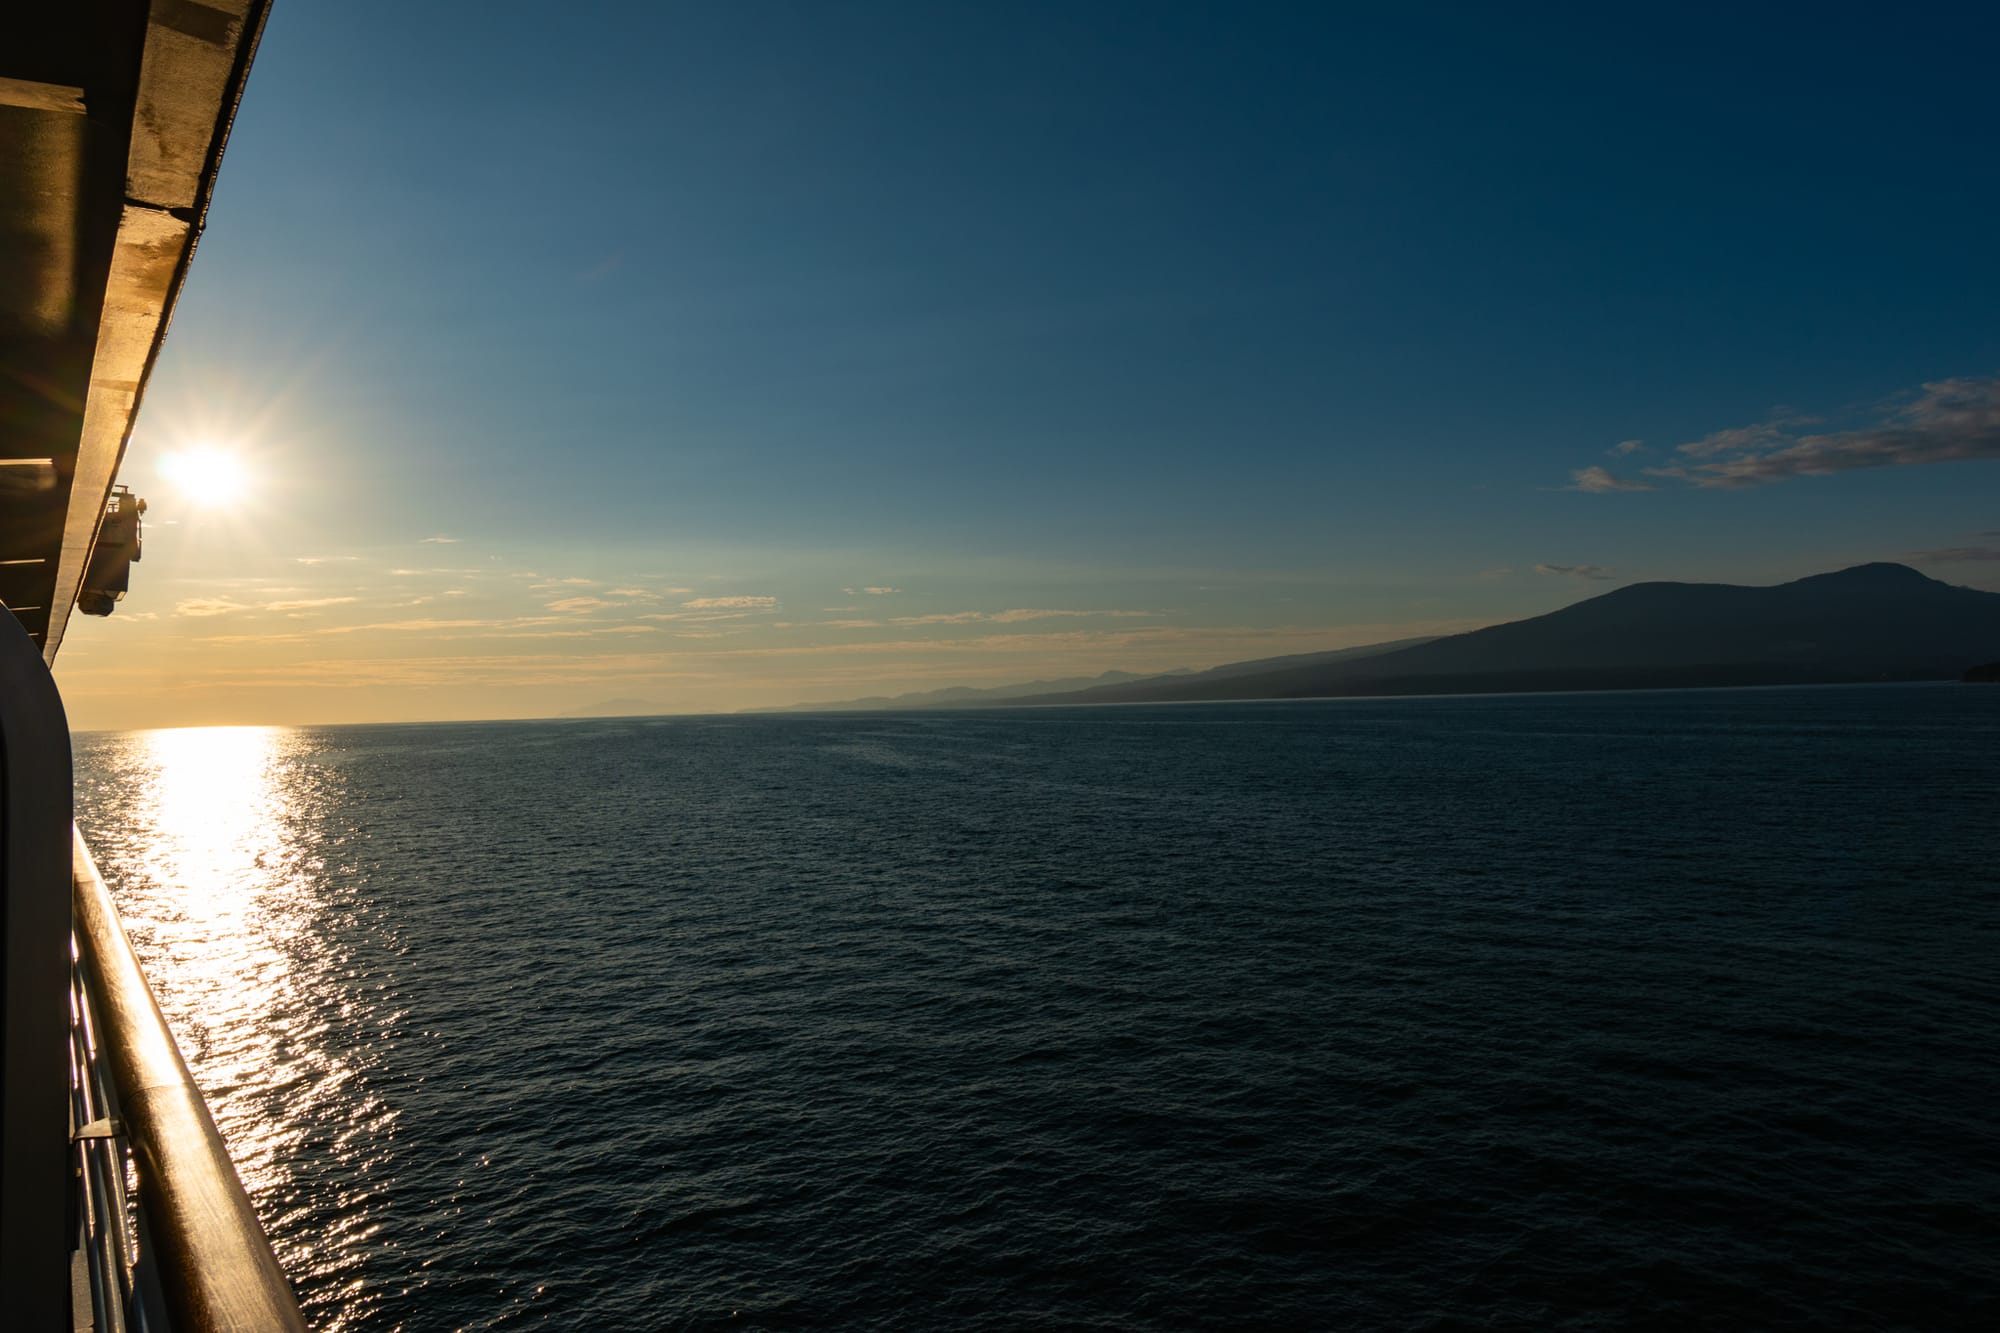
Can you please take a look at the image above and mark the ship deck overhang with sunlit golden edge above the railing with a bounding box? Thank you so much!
[0,0,270,662]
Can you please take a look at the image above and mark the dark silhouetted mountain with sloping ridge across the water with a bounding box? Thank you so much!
[1008,562,2000,705]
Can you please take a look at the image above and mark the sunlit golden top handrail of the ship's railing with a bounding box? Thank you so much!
[72,833,306,1333]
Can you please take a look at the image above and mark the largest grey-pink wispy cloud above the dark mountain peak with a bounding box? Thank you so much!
[1646,374,2000,488]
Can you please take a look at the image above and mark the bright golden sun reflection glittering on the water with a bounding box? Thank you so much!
[78,727,400,1329]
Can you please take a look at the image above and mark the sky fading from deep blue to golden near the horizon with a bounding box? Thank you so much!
[58,2,2000,725]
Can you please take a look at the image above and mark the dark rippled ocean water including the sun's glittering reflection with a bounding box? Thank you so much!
[78,687,2000,1331]
